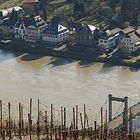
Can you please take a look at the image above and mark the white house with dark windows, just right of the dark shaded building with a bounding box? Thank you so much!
[98,28,122,49]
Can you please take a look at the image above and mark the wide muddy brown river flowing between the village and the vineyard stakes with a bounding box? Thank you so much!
[0,51,140,123]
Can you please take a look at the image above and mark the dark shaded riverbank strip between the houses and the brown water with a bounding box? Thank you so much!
[0,40,140,68]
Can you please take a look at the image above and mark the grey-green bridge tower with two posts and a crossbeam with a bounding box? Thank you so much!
[108,94,128,132]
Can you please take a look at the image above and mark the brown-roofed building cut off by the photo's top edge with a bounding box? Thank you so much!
[22,0,40,15]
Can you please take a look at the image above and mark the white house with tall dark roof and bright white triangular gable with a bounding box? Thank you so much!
[42,16,69,43]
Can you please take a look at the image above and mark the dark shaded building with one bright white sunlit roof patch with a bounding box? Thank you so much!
[76,25,100,46]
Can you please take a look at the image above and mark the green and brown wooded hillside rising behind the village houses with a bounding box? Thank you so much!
[0,0,140,29]
